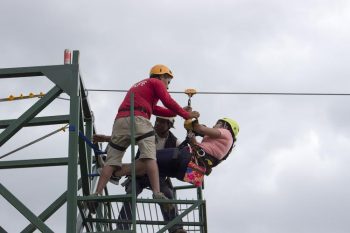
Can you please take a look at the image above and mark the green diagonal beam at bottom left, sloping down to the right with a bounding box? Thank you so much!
[0,183,53,233]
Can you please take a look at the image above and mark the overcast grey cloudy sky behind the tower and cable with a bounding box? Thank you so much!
[0,0,350,233]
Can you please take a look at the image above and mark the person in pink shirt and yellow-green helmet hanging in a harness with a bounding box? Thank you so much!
[110,118,239,186]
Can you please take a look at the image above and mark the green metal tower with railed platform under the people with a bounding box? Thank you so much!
[0,51,207,233]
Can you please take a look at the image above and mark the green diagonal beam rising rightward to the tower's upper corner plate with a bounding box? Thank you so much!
[0,86,62,147]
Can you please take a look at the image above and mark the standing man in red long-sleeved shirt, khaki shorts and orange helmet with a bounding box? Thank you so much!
[89,65,199,213]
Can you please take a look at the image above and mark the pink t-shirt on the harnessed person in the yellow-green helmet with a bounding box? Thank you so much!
[198,128,233,160]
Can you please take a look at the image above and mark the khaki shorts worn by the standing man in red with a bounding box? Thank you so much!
[105,116,156,167]
